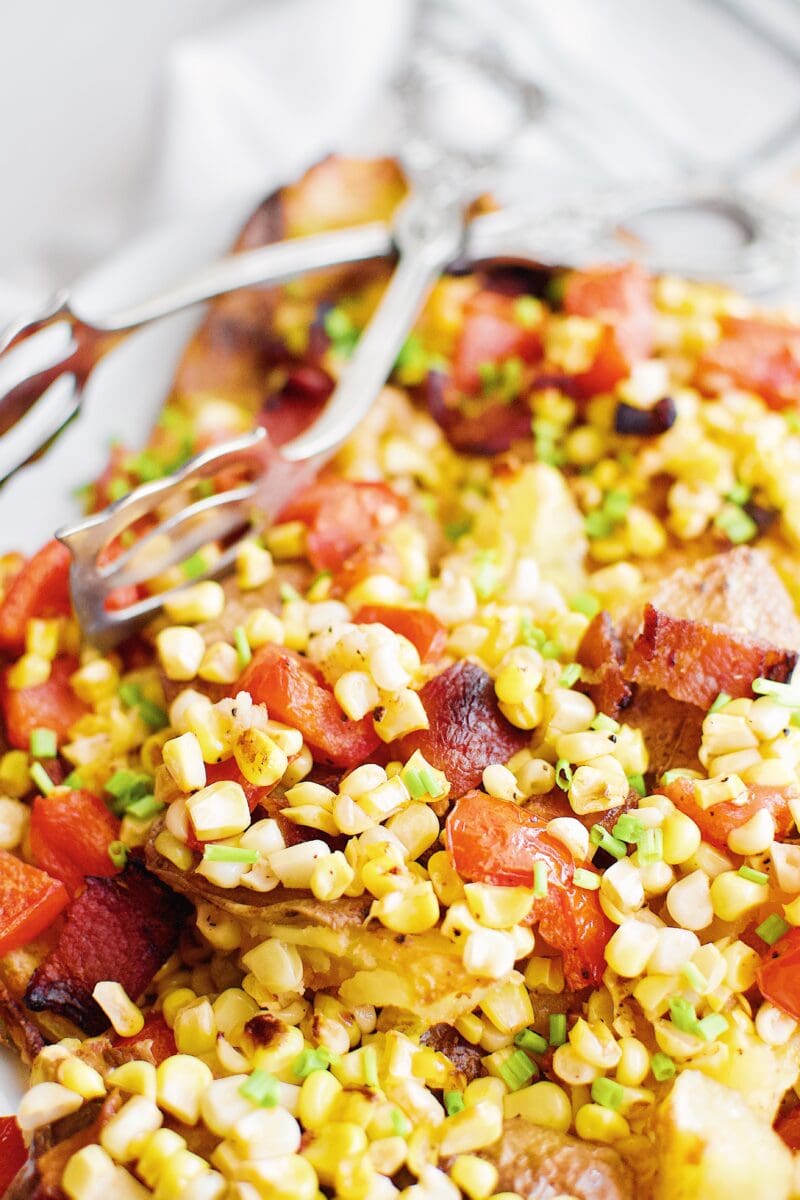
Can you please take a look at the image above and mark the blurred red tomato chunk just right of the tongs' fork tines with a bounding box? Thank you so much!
[281,479,405,571]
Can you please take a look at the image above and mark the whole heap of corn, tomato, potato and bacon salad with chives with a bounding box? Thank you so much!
[0,160,800,1200]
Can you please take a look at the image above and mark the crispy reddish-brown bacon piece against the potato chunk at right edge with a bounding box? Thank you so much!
[625,604,798,708]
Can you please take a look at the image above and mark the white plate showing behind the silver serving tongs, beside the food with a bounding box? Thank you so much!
[0,189,260,1114]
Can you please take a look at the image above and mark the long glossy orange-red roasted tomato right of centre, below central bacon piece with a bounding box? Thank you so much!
[446,791,614,991]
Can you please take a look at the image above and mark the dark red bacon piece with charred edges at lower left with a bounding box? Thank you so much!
[25,859,188,1036]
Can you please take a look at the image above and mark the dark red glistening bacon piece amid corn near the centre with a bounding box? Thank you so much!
[397,661,529,799]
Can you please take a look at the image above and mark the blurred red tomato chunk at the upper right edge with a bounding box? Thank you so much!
[697,317,800,409]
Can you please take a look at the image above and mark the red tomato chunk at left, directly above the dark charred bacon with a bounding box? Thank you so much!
[30,791,120,895]
